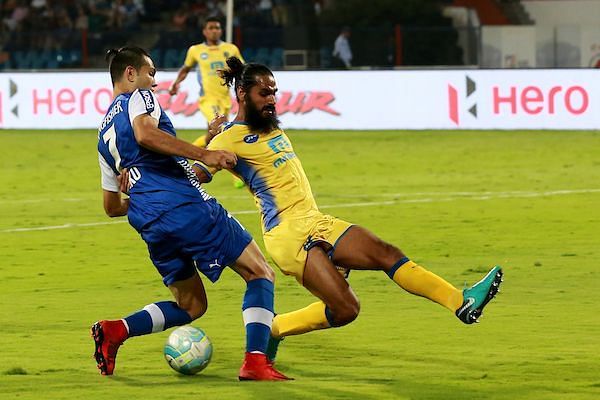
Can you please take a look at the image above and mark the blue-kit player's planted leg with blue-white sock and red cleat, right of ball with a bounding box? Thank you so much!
[231,240,290,380]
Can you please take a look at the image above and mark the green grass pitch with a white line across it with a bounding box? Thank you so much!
[0,130,600,400]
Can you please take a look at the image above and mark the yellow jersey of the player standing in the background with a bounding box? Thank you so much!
[183,42,244,98]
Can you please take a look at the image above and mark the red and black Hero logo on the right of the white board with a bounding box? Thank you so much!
[448,76,590,126]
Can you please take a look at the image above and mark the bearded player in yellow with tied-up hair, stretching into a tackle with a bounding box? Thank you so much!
[195,57,502,361]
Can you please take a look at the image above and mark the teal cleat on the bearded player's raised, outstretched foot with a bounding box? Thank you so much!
[455,266,503,324]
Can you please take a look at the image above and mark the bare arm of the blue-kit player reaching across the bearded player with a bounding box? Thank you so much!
[133,114,237,169]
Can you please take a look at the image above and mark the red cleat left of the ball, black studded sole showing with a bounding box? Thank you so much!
[91,320,127,375]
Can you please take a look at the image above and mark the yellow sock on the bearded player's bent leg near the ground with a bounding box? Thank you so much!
[271,301,331,338]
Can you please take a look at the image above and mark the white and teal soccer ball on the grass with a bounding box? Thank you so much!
[164,325,212,375]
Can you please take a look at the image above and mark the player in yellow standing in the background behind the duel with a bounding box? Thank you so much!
[169,17,244,188]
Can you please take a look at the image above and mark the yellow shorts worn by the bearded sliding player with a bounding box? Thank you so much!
[264,213,352,284]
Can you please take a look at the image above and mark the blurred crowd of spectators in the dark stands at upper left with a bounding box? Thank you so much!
[0,0,300,51]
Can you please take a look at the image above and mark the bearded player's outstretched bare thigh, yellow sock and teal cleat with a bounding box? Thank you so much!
[332,226,502,323]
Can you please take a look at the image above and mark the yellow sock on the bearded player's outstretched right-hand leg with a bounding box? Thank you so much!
[388,258,463,312]
